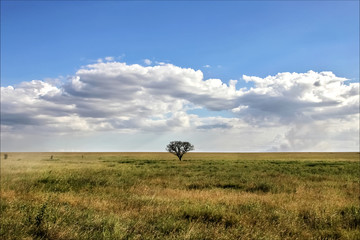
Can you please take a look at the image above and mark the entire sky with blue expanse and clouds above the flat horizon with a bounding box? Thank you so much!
[1,1,359,152]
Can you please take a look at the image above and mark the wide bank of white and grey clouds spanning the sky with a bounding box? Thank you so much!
[1,62,359,151]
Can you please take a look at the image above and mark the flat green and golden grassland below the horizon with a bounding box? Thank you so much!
[0,153,360,240]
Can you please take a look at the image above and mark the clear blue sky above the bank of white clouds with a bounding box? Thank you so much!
[1,1,359,86]
